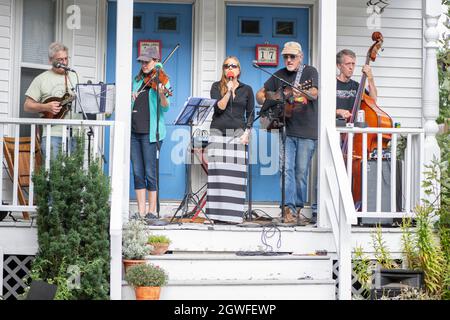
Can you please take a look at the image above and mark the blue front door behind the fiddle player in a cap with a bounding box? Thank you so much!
[106,1,192,200]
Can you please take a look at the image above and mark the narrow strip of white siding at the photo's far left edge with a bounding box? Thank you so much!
[0,0,12,117]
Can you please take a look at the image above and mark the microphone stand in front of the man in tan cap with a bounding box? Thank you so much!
[253,62,303,222]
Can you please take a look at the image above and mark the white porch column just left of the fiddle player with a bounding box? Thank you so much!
[110,0,133,300]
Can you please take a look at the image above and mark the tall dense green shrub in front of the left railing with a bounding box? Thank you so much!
[30,137,110,300]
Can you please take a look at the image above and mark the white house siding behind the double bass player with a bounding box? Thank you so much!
[337,0,423,127]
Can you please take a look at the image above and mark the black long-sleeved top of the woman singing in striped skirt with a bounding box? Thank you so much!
[210,81,255,133]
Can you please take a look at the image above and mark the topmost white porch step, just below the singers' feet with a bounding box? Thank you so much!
[148,223,336,254]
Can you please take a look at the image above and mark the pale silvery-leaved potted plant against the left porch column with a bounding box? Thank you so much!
[122,220,150,272]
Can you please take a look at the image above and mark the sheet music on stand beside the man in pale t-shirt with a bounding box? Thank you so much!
[75,83,116,114]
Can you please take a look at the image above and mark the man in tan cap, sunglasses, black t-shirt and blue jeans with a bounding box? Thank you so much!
[256,41,318,225]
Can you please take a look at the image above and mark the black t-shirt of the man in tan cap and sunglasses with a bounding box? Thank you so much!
[264,65,319,140]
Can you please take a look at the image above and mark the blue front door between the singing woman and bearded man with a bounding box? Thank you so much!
[226,5,310,201]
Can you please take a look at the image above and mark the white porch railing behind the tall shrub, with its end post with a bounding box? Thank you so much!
[0,118,125,299]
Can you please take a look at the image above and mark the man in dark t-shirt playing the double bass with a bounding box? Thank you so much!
[336,49,377,120]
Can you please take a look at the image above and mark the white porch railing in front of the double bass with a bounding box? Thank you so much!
[337,128,425,218]
